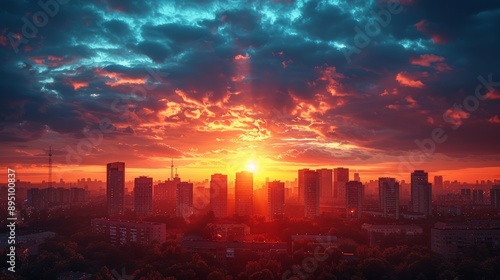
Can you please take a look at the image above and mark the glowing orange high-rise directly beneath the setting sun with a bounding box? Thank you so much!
[234,171,253,216]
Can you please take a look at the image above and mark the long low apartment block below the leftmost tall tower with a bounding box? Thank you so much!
[91,218,167,244]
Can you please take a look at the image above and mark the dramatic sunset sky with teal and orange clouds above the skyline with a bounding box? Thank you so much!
[0,0,500,181]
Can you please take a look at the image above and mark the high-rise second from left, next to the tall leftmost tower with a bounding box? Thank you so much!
[134,176,153,215]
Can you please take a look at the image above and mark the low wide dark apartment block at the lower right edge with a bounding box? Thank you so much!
[431,220,500,258]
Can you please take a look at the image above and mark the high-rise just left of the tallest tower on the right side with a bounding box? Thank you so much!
[378,178,399,219]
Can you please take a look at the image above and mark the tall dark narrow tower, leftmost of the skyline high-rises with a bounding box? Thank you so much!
[106,162,125,216]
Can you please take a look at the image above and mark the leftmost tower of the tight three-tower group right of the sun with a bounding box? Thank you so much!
[303,170,320,219]
